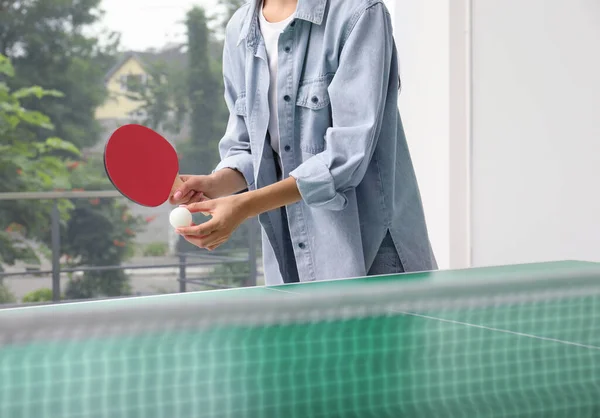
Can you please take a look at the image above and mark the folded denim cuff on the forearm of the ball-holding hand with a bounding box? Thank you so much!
[290,156,348,210]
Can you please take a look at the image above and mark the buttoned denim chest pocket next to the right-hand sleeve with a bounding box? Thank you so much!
[296,74,333,154]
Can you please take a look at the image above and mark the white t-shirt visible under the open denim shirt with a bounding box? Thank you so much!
[259,7,295,154]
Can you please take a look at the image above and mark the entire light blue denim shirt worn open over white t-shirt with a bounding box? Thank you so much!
[216,0,437,285]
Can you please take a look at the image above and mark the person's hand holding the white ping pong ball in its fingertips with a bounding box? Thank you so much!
[177,195,250,251]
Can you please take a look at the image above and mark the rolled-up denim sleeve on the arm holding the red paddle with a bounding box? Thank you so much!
[213,36,254,189]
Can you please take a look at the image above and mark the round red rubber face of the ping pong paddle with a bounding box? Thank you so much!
[104,124,179,207]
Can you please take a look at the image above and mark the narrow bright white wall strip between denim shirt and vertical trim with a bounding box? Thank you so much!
[386,0,450,268]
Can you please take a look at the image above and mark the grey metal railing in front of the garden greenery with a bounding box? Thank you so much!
[0,190,258,303]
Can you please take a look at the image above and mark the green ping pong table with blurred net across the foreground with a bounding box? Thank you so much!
[0,261,600,418]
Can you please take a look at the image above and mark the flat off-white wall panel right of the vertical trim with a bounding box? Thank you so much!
[472,0,600,265]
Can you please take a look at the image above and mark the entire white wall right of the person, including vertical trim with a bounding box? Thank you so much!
[386,0,600,268]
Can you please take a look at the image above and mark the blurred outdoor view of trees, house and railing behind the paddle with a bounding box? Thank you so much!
[0,0,261,303]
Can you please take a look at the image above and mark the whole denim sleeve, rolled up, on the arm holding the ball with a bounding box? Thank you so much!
[290,3,394,210]
